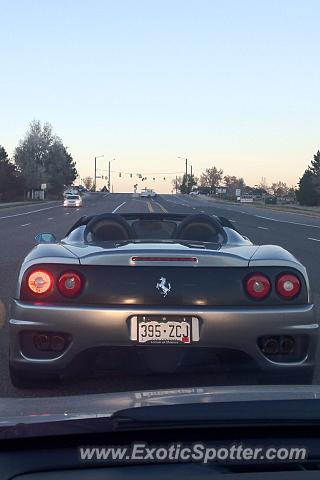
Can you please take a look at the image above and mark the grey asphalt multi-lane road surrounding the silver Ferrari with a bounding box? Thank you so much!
[0,193,320,397]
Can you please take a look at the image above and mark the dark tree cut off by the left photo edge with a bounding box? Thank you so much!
[0,145,24,201]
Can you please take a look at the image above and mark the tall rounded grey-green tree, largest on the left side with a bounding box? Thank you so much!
[14,120,77,195]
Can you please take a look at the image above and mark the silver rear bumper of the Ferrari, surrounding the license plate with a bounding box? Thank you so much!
[9,300,319,375]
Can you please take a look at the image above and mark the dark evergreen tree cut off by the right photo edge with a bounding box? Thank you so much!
[296,150,320,206]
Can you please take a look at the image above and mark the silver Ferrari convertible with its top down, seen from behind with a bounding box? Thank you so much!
[9,213,318,388]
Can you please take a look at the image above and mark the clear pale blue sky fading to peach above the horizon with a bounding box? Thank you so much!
[0,0,320,193]
